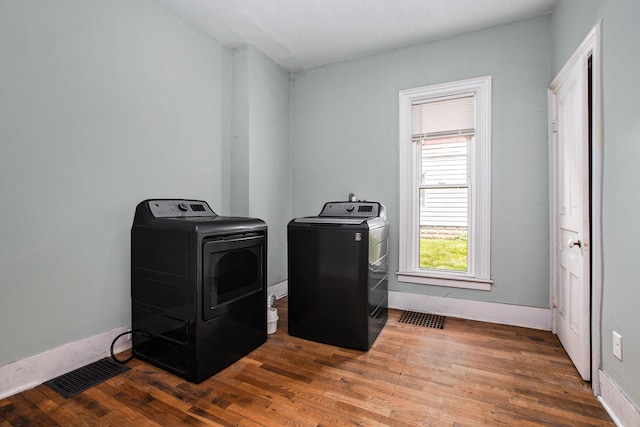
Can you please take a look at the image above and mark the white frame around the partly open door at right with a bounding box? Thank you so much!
[547,21,603,395]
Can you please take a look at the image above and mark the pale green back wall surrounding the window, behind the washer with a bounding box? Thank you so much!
[291,16,550,307]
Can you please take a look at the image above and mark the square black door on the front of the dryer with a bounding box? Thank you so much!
[202,235,265,320]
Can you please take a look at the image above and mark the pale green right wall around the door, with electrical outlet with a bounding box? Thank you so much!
[552,0,640,407]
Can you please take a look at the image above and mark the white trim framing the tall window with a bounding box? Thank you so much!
[397,76,492,290]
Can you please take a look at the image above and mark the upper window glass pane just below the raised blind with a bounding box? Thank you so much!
[420,136,470,185]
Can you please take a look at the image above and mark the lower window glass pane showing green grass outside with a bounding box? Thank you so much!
[419,186,469,271]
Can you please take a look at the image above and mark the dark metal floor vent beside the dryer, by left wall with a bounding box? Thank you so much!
[44,357,129,398]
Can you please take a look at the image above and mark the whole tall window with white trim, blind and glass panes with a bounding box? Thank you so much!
[398,77,491,290]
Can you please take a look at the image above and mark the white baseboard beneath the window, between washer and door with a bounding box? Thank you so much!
[389,291,551,331]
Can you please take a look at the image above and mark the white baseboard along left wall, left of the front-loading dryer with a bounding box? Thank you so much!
[0,326,131,399]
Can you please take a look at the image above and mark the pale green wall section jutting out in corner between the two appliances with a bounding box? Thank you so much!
[230,46,291,285]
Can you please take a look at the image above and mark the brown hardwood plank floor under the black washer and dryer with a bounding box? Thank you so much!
[0,299,614,426]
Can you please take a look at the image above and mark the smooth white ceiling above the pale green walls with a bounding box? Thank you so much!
[158,0,558,71]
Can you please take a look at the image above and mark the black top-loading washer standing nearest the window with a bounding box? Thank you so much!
[287,202,389,350]
